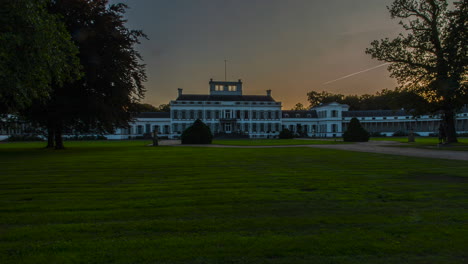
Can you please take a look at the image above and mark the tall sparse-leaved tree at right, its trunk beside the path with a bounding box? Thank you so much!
[366,0,468,142]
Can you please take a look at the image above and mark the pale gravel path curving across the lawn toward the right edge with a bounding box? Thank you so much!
[160,140,468,161]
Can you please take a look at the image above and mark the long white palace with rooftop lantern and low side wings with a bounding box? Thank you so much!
[0,80,468,140]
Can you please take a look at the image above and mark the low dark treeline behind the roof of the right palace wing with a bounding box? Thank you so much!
[307,89,426,111]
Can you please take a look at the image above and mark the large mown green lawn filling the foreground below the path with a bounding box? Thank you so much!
[0,141,468,264]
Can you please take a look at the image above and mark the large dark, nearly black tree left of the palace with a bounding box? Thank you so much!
[25,0,146,149]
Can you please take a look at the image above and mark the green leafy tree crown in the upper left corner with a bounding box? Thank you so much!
[0,0,80,113]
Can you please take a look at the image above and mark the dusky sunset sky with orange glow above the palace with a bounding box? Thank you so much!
[116,0,401,110]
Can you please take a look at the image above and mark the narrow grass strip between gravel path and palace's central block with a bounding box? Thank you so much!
[213,138,346,146]
